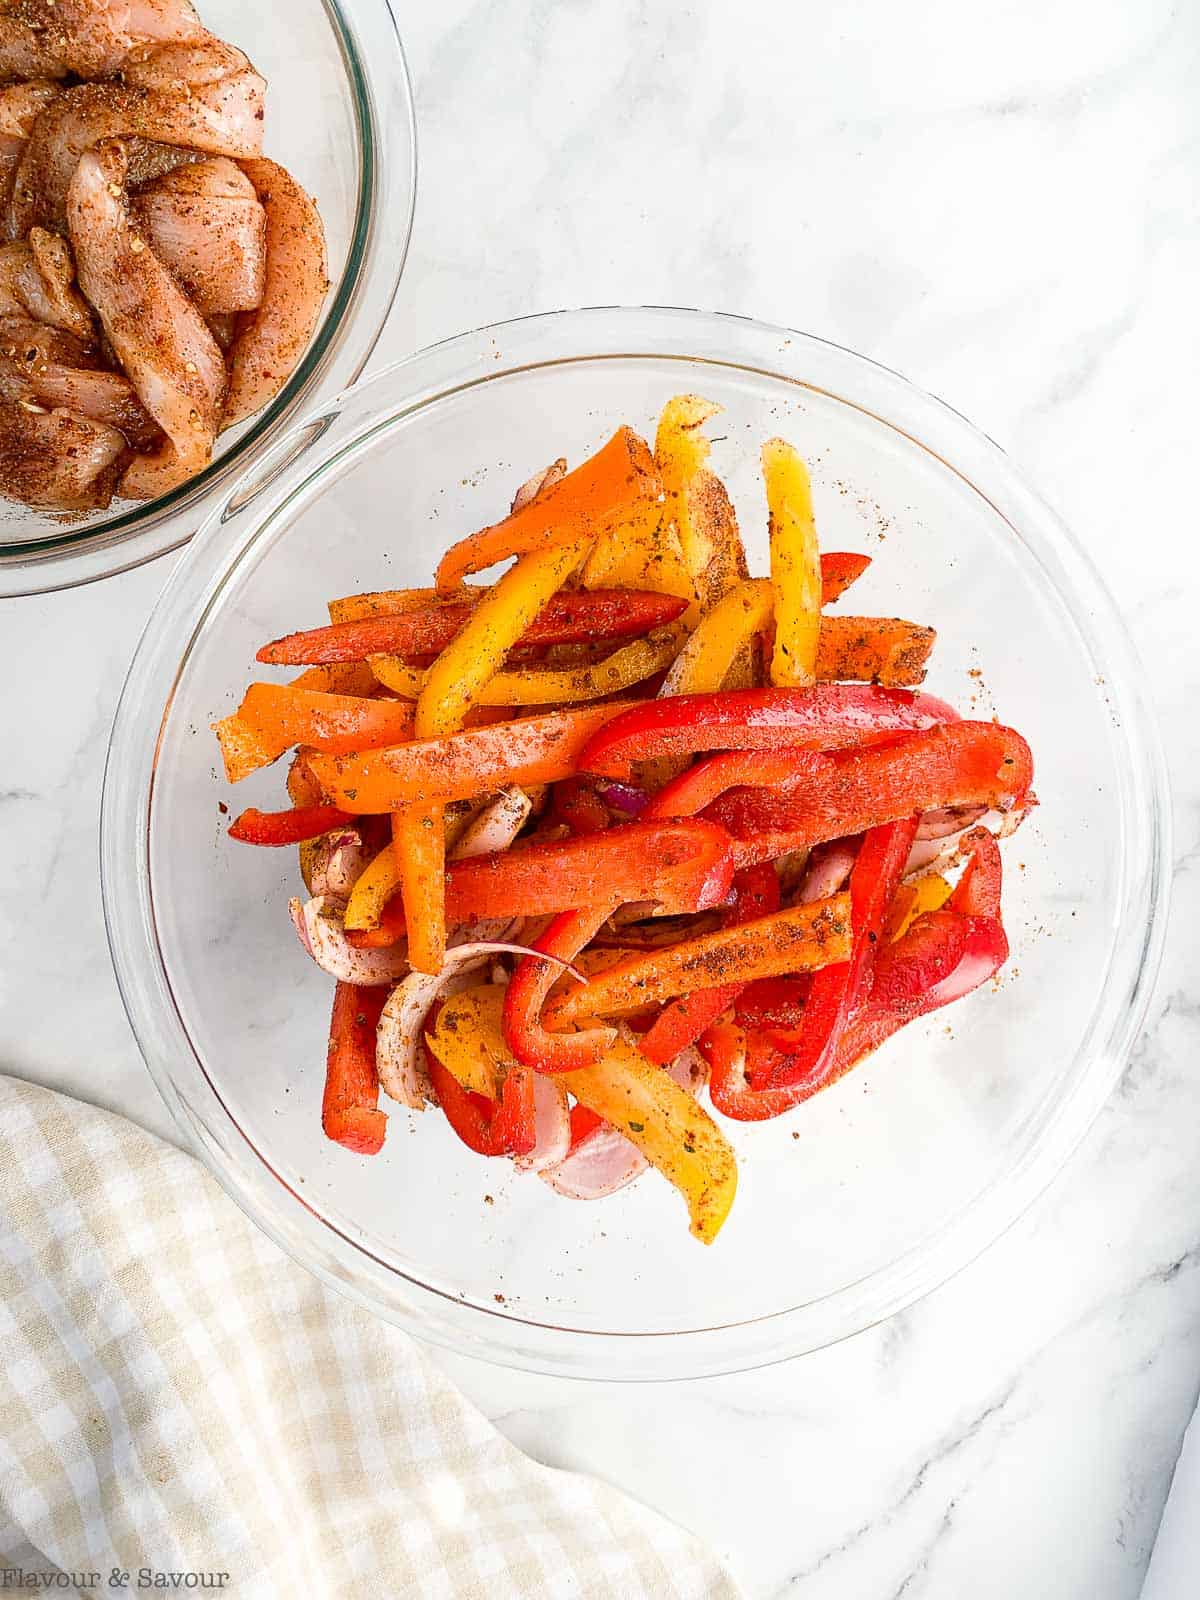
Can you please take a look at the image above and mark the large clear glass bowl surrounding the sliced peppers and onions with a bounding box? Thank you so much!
[102,309,1166,1379]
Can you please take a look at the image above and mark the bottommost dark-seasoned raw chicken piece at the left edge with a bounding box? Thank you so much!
[0,402,128,510]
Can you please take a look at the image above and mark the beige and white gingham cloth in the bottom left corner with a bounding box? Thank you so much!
[0,1077,738,1600]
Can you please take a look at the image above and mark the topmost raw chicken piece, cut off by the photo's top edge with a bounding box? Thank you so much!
[0,0,205,78]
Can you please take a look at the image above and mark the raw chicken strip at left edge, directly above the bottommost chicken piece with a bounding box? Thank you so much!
[0,313,162,450]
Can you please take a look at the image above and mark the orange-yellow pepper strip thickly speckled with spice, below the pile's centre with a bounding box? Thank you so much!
[542,893,851,1027]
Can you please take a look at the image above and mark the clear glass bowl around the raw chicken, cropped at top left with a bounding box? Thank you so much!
[0,0,416,597]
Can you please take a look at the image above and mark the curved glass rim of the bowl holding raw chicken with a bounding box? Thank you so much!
[0,0,418,598]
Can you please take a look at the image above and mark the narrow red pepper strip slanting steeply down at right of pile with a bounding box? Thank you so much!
[761,816,920,1090]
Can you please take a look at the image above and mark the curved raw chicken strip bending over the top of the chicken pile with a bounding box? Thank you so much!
[8,38,266,238]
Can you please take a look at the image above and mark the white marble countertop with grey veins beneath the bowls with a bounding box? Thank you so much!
[0,0,1200,1600]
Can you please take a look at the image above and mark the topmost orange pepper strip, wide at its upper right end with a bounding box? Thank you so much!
[437,427,661,590]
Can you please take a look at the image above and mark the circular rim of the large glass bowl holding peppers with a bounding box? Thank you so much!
[101,307,1170,1381]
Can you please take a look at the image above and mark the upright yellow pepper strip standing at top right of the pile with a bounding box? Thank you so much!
[762,438,821,688]
